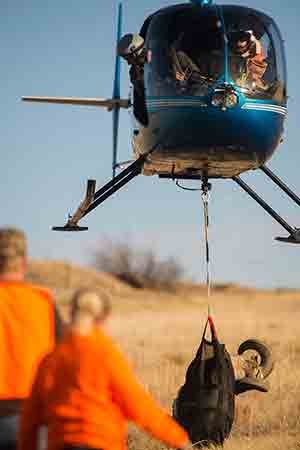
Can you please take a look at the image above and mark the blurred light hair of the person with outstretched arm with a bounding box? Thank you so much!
[71,288,111,321]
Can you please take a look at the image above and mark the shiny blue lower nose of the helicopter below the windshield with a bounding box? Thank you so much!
[144,102,283,172]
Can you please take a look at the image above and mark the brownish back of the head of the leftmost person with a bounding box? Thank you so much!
[0,227,27,274]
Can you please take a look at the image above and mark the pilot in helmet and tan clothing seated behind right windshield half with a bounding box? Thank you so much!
[230,30,268,90]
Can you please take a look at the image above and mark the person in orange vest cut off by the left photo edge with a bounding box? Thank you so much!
[0,228,61,450]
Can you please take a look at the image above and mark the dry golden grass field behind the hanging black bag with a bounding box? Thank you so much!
[28,260,300,450]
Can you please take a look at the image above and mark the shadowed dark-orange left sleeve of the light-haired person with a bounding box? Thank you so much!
[17,357,48,450]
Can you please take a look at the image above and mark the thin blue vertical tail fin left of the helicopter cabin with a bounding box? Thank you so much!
[112,2,123,178]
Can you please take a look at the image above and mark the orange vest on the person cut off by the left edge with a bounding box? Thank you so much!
[0,281,55,400]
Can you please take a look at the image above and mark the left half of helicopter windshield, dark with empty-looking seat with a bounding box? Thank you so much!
[145,7,224,96]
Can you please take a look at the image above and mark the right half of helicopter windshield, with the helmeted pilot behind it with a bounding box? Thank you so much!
[223,6,286,102]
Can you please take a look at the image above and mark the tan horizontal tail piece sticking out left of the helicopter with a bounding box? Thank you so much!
[22,97,130,111]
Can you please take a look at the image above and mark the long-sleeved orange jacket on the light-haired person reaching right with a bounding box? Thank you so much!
[18,329,188,450]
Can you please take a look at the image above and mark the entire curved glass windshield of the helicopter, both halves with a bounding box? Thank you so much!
[142,5,286,104]
